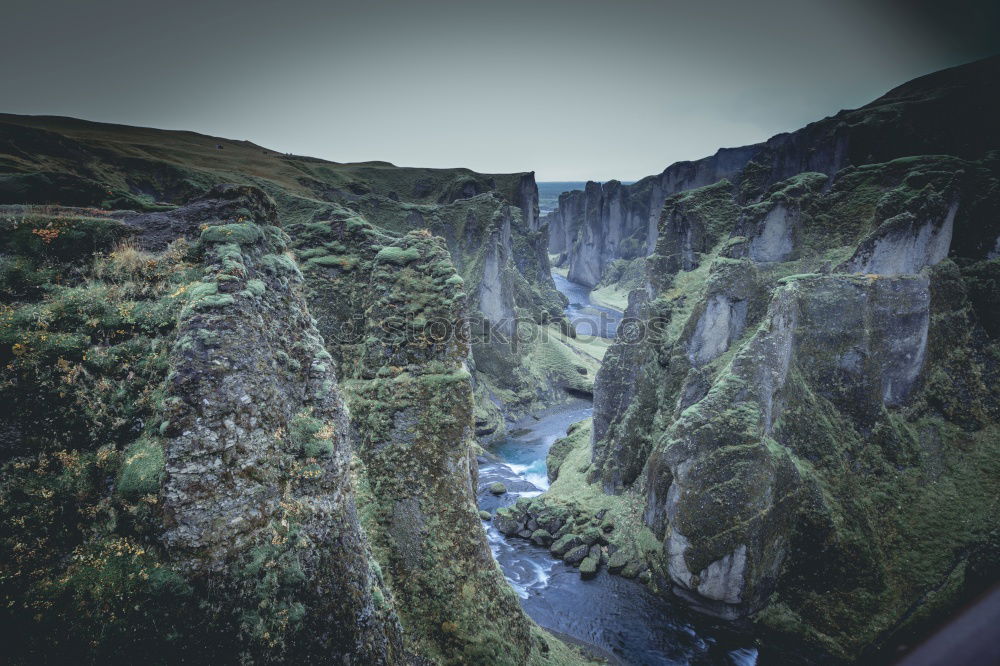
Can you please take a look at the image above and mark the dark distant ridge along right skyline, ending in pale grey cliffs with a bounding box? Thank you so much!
[542,58,1000,286]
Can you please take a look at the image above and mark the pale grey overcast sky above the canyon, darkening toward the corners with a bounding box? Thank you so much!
[0,0,1000,181]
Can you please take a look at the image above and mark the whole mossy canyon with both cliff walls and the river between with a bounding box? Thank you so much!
[0,57,1000,666]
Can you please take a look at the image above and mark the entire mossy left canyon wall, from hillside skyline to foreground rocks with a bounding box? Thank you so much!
[0,123,592,664]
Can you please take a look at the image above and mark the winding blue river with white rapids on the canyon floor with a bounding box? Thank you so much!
[479,274,757,666]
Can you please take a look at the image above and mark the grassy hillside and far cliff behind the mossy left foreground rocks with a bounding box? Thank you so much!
[0,115,572,439]
